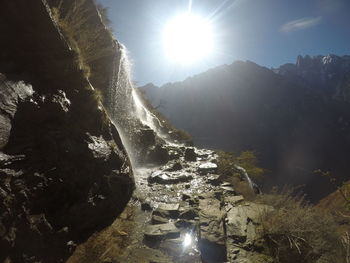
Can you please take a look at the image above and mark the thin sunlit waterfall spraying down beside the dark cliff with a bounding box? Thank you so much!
[107,45,174,165]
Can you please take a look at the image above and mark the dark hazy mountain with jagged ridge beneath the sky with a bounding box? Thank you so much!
[141,55,350,200]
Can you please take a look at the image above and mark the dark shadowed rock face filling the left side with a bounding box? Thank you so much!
[0,0,134,262]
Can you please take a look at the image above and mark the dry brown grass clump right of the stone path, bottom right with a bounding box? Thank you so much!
[256,190,346,263]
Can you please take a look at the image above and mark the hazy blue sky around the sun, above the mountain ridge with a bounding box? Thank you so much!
[99,0,350,85]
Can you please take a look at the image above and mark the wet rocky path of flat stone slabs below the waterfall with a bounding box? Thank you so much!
[67,146,274,263]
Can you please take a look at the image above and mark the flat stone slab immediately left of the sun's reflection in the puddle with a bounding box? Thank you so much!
[144,223,180,241]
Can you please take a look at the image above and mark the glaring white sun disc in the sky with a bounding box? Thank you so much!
[163,13,213,64]
